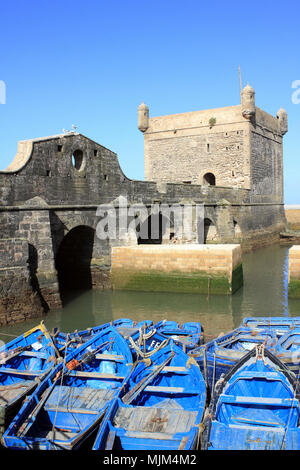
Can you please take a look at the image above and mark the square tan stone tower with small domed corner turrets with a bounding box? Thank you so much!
[138,84,288,203]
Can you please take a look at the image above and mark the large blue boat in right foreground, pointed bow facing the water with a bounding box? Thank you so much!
[201,345,300,450]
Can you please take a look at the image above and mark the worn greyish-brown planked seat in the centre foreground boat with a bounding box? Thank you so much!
[113,406,197,439]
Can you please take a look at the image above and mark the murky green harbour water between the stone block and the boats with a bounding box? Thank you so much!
[0,245,300,341]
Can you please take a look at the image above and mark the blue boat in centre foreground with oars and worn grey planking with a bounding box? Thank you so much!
[93,340,206,450]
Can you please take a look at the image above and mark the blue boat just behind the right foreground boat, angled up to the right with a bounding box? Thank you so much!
[189,327,276,391]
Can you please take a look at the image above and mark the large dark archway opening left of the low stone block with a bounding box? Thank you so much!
[55,225,95,304]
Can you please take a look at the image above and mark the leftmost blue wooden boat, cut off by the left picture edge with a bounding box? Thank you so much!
[0,322,58,434]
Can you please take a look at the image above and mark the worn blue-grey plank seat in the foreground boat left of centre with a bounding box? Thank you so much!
[45,385,114,414]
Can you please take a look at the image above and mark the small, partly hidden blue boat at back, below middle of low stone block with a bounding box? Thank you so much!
[153,320,204,352]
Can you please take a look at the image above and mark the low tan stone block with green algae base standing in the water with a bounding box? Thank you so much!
[111,245,243,294]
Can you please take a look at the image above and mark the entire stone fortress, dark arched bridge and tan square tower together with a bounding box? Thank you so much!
[0,85,287,325]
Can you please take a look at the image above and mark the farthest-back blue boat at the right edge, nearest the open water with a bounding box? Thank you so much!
[241,317,300,338]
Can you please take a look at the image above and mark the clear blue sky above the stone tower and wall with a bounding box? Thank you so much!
[0,0,300,204]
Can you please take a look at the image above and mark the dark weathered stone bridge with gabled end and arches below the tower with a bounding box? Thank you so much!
[0,133,286,325]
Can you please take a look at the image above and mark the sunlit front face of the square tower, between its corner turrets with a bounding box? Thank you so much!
[144,106,250,188]
